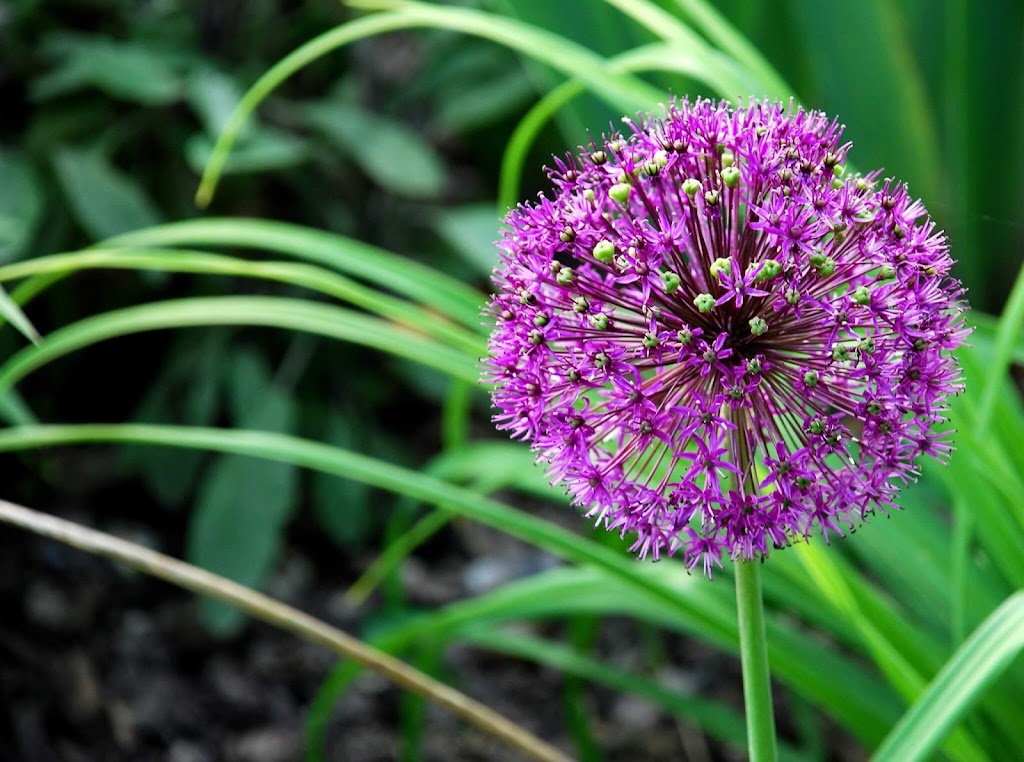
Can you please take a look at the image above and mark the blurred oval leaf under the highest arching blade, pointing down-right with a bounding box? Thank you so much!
[305,101,444,200]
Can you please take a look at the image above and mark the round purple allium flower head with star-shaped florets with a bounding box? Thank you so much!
[486,100,968,575]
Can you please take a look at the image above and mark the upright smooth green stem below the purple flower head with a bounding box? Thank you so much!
[735,559,777,762]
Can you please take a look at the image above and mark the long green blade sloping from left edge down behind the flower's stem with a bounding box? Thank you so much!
[0,424,897,744]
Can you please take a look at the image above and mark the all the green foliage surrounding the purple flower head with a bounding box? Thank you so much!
[6,0,1024,760]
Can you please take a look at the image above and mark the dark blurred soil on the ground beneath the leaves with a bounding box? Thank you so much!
[0,446,856,762]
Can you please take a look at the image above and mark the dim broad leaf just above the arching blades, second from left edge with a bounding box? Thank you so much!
[53,149,160,239]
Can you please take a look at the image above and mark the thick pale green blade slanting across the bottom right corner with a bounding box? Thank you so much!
[872,592,1024,762]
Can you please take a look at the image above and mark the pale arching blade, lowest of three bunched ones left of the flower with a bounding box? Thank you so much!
[0,296,479,393]
